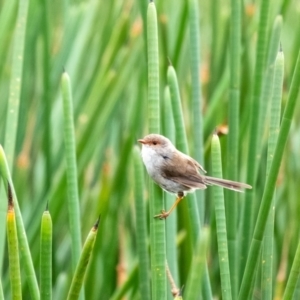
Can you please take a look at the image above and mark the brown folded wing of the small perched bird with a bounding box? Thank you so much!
[162,152,206,189]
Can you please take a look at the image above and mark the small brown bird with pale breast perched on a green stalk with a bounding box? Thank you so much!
[138,134,252,219]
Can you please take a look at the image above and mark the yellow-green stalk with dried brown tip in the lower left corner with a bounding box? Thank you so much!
[6,183,22,300]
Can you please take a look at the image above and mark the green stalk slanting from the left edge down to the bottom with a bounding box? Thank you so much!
[0,145,40,300]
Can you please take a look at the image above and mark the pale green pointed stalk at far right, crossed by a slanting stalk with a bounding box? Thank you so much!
[261,50,284,300]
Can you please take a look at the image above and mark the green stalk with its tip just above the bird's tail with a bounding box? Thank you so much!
[211,134,232,300]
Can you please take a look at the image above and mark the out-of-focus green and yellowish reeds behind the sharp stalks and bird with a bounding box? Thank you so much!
[0,0,300,299]
